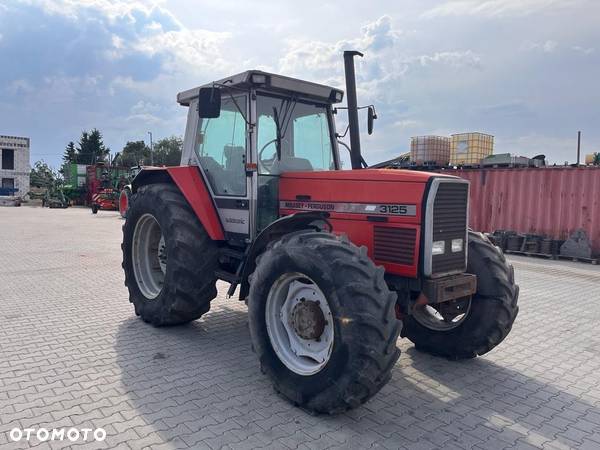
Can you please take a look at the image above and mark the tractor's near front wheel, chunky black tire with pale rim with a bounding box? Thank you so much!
[248,231,401,414]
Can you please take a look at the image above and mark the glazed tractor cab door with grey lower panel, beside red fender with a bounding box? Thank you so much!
[194,93,252,243]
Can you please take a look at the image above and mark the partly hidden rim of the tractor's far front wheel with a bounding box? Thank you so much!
[413,297,471,331]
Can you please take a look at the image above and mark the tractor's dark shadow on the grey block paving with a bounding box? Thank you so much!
[115,300,600,448]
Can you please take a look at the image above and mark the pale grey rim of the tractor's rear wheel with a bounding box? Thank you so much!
[131,214,167,300]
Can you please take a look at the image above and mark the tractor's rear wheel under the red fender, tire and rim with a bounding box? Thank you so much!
[121,184,217,326]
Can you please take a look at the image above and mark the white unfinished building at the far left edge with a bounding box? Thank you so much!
[0,135,31,197]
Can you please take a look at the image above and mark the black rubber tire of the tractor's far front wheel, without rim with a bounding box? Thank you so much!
[402,231,519,360]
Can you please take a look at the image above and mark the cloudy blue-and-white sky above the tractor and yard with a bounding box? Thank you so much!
[0,0,600,167]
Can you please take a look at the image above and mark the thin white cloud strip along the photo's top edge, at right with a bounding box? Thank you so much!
[423,0,587,18]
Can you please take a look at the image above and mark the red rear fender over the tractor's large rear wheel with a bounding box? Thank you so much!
[131,166,225,241]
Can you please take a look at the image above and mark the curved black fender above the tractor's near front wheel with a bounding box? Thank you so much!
[240,211,332,300]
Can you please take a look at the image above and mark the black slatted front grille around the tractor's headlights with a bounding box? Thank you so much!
[431,182,469,274]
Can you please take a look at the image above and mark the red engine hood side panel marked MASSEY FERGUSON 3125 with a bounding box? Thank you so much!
[279,174,427,278]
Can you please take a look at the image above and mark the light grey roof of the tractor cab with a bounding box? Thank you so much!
[177,70,344,106]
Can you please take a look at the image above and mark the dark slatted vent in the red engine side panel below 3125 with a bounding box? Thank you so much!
[373,226,417,266]
